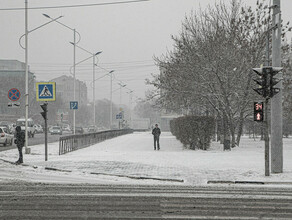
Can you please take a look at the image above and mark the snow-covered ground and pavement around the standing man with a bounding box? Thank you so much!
[0,132,292,185]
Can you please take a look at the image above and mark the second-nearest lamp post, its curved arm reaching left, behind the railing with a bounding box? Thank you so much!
[43,14,81,134]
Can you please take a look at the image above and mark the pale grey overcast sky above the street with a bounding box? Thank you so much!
[0,0,292,103]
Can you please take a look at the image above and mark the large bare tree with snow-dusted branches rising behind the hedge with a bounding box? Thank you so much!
[148,0,288,148]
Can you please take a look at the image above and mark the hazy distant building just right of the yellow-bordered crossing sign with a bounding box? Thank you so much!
[50,75,87,108]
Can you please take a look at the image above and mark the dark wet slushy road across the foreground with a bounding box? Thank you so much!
[0,182,292,220]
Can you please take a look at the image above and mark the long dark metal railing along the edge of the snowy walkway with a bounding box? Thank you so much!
[59,129,133,155]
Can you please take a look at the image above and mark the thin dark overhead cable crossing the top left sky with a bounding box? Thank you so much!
[0,0,150,11]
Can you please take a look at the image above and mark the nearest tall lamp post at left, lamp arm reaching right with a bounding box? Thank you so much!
[19,7,63,154]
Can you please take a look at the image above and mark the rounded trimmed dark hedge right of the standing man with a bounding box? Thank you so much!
[170,116,215,150]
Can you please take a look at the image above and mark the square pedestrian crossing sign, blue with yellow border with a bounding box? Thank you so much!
[36,82,56,101]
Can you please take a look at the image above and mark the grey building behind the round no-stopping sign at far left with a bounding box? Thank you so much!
[0,60,35,121]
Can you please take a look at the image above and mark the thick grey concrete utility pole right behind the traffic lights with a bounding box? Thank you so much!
[271,0,283,173]
